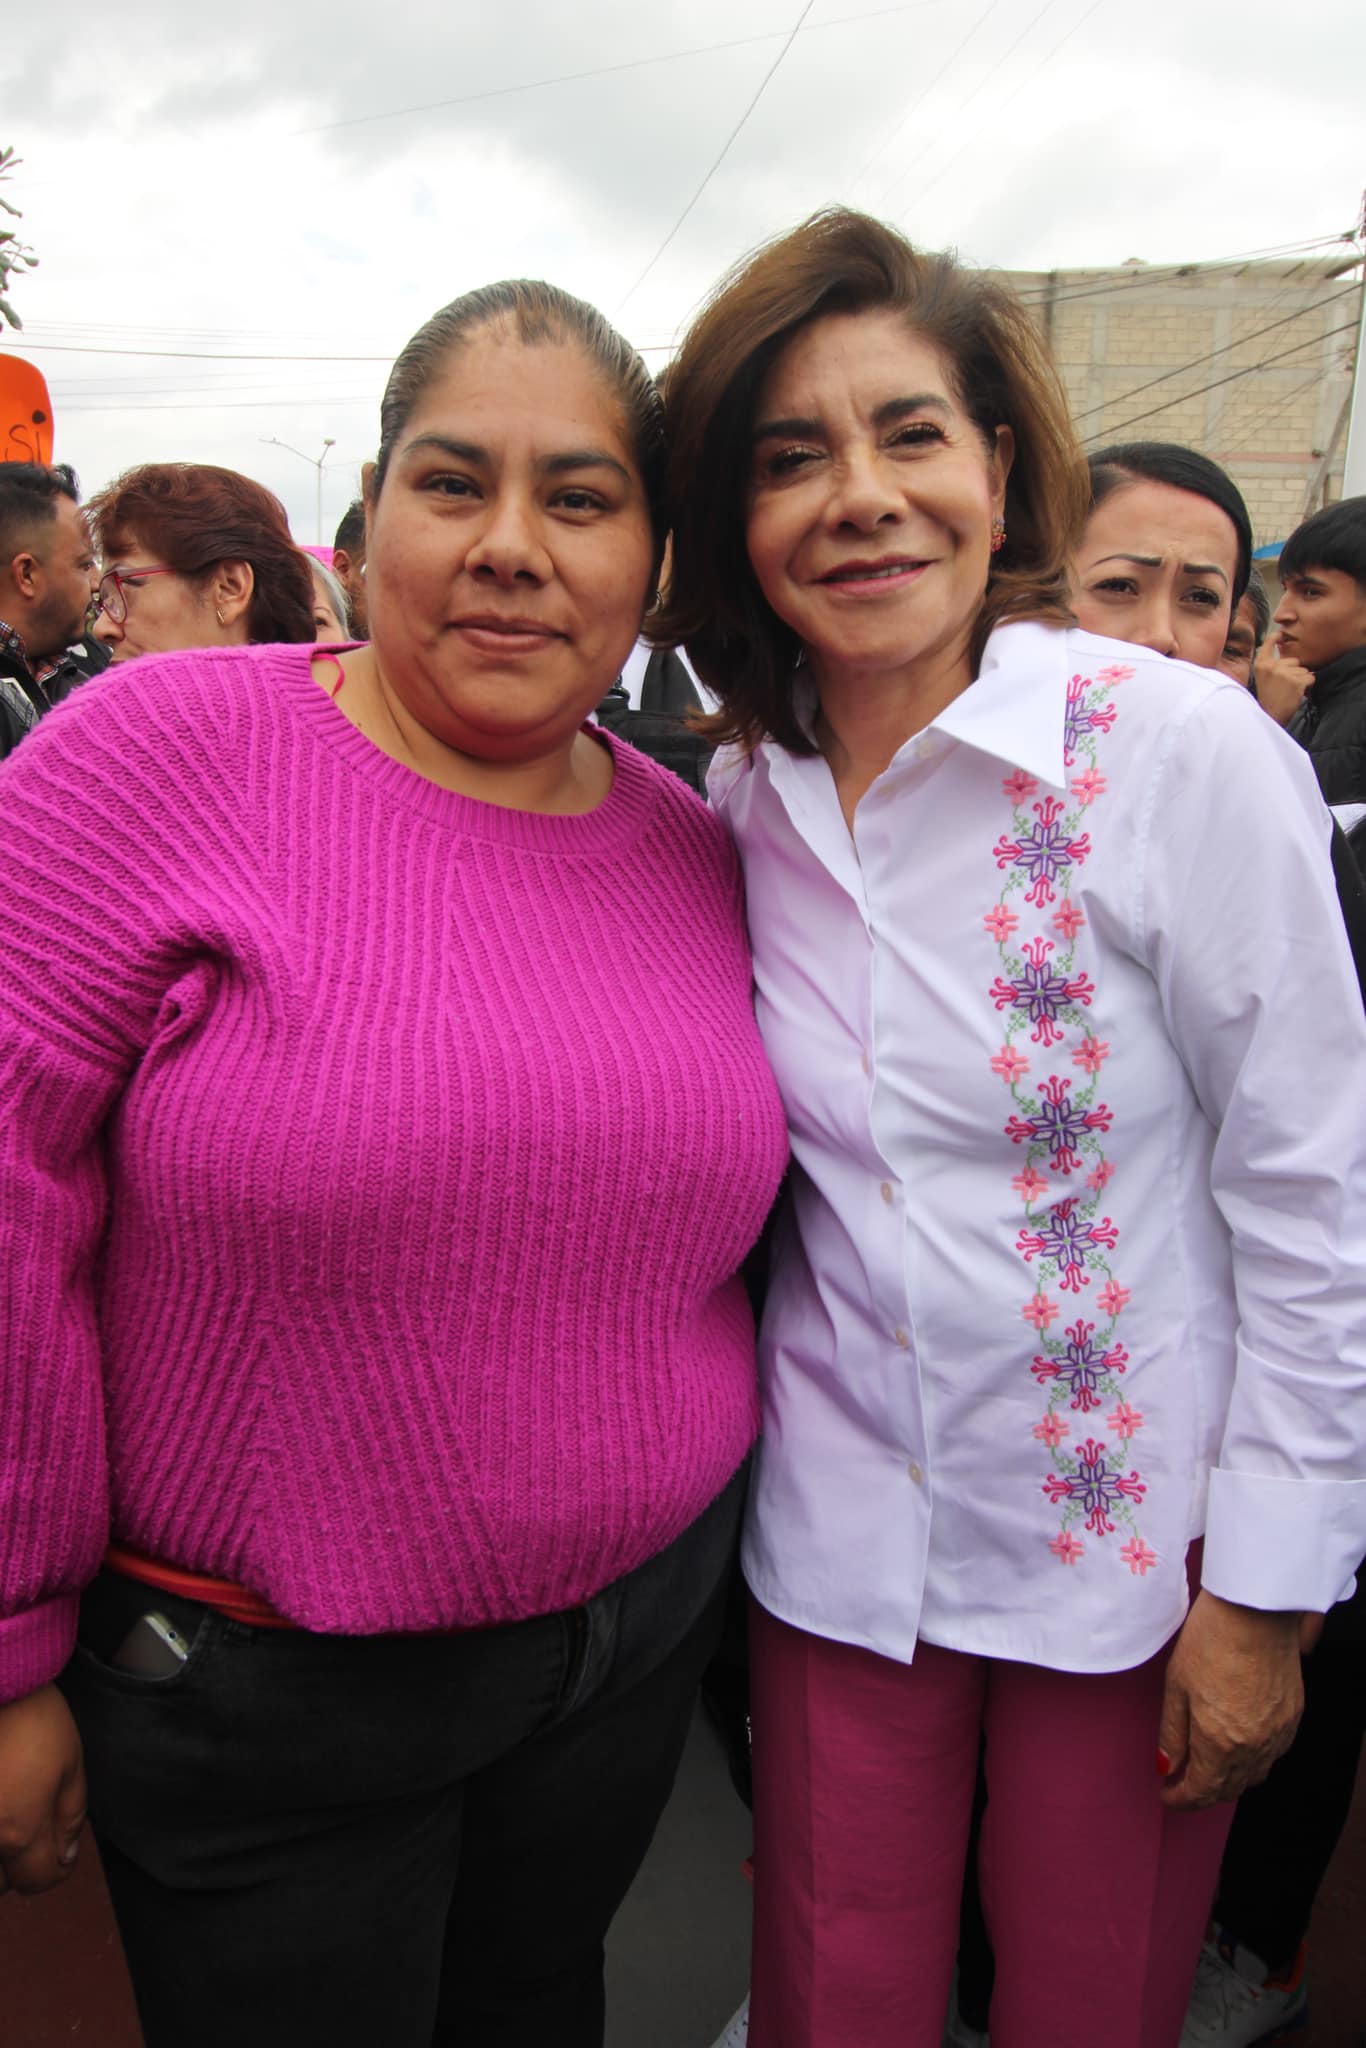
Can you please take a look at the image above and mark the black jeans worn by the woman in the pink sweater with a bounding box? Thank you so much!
[61,1470,745,2048]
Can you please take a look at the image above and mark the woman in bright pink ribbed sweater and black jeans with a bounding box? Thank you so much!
[0,285,786,2048]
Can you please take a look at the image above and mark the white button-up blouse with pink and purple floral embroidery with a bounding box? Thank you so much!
[713,625,1366,1671]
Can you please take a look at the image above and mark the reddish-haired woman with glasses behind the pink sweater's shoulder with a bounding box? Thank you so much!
[90,463,317,662]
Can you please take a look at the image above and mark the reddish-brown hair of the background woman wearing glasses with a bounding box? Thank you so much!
[88,463,313,641]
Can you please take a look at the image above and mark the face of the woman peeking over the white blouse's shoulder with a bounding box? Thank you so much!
[1071,477,1237,668]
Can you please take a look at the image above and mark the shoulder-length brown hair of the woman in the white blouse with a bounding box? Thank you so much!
[649,207,1090,754]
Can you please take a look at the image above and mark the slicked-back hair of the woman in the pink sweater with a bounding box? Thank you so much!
[367,276,666,555]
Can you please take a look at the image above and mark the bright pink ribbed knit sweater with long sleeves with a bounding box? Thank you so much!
[0,647,786,1698]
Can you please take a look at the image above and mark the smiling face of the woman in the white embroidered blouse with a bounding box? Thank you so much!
[745,311,1014,682]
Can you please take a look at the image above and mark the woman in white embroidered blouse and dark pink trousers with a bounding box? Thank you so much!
[657,211,1366,2048]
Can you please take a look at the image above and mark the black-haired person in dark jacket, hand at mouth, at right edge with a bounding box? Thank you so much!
[1257,498,1366,761]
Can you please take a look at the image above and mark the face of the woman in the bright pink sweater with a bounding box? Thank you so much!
[367,324,653,760]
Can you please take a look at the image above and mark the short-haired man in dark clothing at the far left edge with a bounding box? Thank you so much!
[0,463,102,756]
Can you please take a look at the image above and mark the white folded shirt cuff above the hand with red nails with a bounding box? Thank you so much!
[1200,1466,1366,1614]
